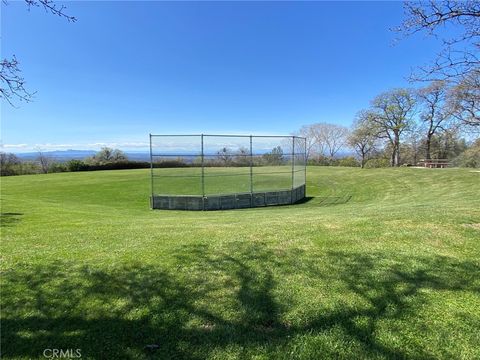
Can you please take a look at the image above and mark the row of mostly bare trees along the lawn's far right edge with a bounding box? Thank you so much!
[297,81,480,167]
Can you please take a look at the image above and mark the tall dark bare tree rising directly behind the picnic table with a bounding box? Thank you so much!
[417,81,452,160]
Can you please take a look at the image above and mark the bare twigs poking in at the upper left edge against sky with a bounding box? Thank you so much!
[0,0,77,106]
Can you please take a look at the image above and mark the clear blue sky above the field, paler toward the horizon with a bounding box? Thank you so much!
[1,1,446,151]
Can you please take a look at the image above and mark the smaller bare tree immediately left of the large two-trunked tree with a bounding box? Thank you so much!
[347,110,378,169]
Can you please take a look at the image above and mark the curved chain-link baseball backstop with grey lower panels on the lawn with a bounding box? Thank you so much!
[150,134,306,210]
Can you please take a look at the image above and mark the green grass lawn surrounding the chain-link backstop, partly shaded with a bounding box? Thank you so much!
[1,167,480,359]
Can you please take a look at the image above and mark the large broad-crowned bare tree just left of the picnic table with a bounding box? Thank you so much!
[370,89,416,166]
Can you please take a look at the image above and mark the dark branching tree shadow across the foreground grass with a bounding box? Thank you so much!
[2,242,480,359]
